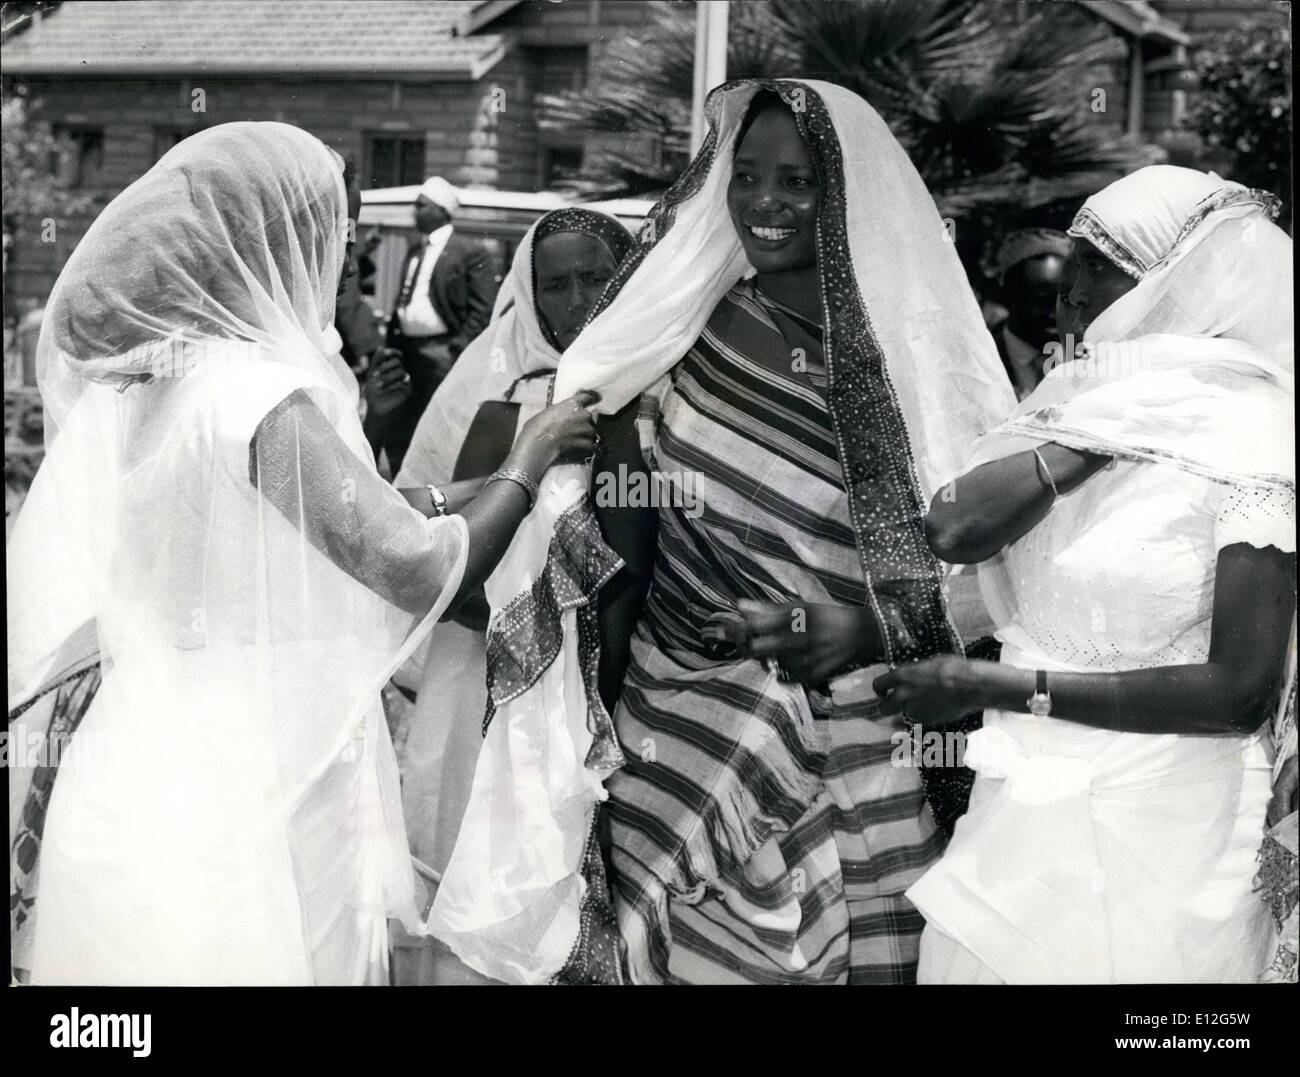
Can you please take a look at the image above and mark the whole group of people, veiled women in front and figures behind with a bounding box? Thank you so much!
[9,73,1296,985]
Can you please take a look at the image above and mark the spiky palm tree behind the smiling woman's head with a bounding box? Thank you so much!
[540,0,1158,282]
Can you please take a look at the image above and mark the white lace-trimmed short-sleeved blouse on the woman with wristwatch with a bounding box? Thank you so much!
[979,460,1296,671]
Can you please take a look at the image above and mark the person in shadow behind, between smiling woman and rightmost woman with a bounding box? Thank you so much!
[993,228,1070,401]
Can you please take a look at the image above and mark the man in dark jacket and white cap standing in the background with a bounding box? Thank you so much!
[368,176,498,475]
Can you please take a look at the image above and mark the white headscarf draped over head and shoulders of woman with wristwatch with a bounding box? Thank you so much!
[969,165,1295,489]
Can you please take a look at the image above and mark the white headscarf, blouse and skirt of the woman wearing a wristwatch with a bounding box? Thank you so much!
[907,166,1295,983]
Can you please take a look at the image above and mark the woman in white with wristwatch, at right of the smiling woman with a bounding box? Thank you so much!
[878,166,1295,983]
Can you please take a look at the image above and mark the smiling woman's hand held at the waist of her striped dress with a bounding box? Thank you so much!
[737,601,880,684]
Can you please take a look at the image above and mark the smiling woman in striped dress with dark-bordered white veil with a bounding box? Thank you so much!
[593,79,1014,983]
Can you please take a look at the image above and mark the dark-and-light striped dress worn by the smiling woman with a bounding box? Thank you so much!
[607,281,941,983]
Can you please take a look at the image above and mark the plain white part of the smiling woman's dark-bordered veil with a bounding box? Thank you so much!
[432,79,1014,982]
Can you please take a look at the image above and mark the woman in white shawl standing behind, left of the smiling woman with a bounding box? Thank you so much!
[394,207,632,982]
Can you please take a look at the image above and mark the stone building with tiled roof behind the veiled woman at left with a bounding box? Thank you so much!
[0,0,646,310]
